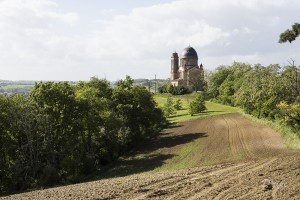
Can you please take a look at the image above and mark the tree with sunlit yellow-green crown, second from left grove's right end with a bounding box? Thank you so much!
[75,77,120,170]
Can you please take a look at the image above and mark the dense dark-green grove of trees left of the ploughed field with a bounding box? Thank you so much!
[0,77,165,194]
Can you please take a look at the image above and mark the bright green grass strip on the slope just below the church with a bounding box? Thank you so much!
[154,94,242,123]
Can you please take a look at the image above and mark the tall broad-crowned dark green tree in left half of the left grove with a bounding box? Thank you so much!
[30,82,82,185]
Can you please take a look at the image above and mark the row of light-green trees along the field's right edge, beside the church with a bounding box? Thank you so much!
[207,61,300,128]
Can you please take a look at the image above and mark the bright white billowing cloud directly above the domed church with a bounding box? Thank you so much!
[88,1,229,60]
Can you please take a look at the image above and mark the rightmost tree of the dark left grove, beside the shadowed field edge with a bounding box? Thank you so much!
[112,76,165,150]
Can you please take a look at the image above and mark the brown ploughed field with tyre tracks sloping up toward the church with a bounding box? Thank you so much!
[3,114,300,199]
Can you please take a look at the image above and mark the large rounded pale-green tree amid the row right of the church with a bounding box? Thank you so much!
[234,64,285,119]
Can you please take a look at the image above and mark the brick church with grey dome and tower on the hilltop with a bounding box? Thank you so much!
[171,46,204,91]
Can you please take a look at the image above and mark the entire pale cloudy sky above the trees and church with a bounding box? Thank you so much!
[0,0,300,81]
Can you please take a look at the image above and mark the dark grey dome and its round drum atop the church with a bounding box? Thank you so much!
[180,46,198,70]
